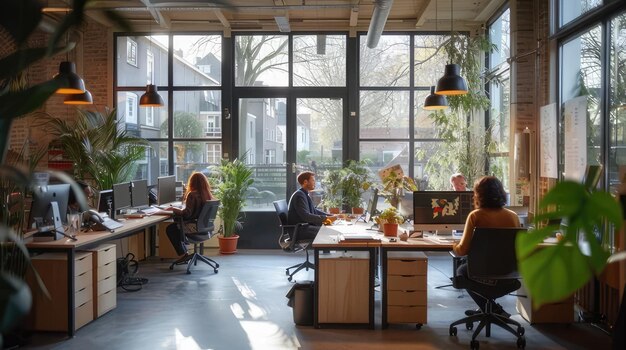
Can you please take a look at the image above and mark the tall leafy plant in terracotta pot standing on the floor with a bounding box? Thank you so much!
[215,157,254,254]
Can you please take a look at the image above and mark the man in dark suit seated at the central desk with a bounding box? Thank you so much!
[287,171,332,239]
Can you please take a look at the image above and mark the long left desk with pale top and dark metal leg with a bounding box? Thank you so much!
[25,215,169,337]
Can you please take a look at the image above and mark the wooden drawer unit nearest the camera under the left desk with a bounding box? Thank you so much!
[27,252,94,332]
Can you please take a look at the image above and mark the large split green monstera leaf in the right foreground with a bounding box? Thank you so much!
[516,181,623,305]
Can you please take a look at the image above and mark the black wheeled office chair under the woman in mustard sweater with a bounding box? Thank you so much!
[450,228,526,349]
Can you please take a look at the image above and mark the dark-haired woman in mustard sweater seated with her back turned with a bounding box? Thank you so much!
[452,176,520,317]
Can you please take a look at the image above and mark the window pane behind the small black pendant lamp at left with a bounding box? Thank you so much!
[117,90,169,139]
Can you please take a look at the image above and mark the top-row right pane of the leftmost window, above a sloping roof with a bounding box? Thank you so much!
[174,35,222,86]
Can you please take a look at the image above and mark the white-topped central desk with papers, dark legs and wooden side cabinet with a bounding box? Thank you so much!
[313,223,453,329]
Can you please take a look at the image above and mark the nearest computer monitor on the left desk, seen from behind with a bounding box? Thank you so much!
[28,184,70,230]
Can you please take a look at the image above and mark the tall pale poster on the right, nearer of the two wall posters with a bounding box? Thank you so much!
[563,96,587,181]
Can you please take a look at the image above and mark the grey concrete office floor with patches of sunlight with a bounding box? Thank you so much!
[19,250,611,350]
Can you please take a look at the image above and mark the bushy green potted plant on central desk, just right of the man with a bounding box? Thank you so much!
[341,160,372,214]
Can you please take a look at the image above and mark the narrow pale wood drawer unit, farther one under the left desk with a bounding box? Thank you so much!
[85,244,117,317]
